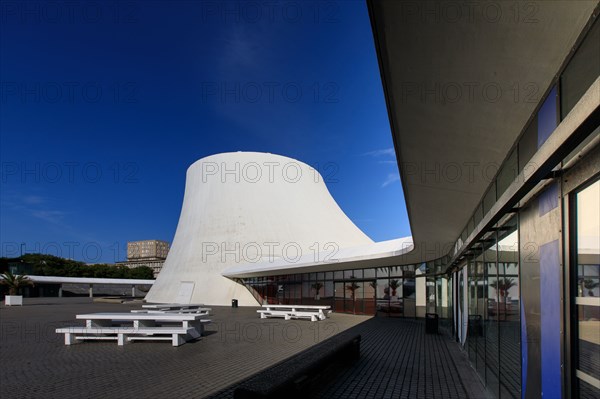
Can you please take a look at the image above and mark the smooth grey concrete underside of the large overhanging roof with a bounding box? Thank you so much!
[368,0,598,261]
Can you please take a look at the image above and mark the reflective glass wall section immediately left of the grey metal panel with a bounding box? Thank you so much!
[456,216,521,398]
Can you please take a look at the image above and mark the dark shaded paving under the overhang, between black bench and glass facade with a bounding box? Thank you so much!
[212,317,489,399]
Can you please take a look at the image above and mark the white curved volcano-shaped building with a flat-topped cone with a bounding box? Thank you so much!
[146,152,373,305]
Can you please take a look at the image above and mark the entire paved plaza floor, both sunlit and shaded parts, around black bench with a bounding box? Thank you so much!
[0,298,484,398]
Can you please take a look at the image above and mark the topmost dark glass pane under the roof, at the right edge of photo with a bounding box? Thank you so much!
[560,21,600,119]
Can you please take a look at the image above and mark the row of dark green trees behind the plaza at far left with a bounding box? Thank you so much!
[0,254,154,279]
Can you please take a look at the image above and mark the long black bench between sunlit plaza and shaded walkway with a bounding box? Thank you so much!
[233,333,361,399]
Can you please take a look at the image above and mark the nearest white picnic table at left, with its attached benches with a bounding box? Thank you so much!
[56,312,210,346]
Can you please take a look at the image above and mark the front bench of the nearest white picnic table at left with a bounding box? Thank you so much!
[56,327,200,346]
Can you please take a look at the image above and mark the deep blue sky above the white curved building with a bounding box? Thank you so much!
[0,1,410,263]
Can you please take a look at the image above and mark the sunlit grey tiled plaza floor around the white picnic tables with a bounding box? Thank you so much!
[0,298,368,399]
